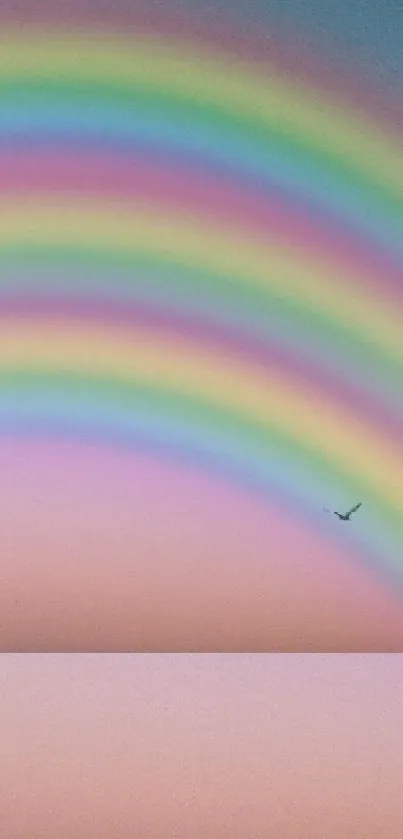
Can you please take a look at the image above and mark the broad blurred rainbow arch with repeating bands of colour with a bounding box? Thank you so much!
[0,9,403,584]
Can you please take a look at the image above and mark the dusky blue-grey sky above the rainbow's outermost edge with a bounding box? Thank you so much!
[2,0,403,86]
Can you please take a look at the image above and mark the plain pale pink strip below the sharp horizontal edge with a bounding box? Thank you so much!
[0,655,403,839]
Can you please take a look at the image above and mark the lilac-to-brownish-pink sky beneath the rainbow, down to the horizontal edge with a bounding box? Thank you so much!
[0,441,403,652]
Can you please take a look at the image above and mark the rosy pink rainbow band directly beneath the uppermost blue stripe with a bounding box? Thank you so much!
[0,148,403,305]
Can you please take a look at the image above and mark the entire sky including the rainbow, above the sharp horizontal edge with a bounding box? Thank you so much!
[0,0,403,648]
